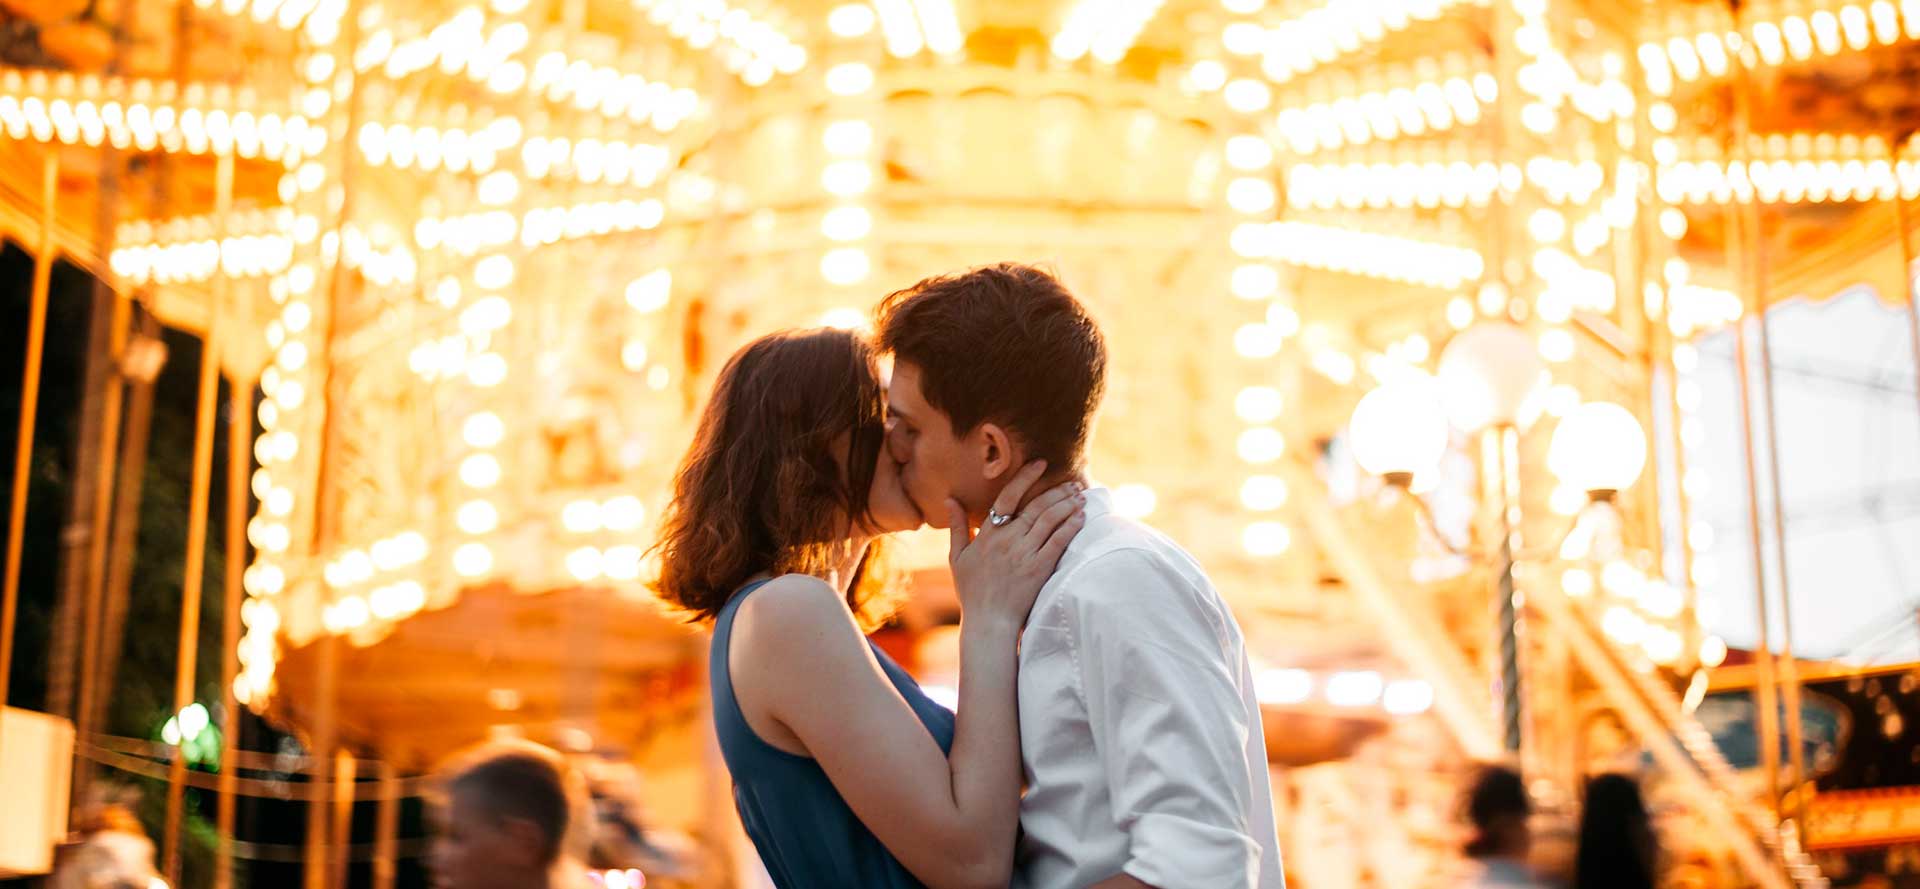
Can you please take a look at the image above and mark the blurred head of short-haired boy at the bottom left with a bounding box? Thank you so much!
[428,743,580,889]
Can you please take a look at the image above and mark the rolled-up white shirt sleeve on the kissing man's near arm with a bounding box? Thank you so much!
[1068,549,1267,889]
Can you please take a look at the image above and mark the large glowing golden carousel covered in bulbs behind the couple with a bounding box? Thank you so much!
[0,0,1920,889]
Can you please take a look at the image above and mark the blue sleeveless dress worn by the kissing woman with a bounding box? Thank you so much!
[708,580,954,889]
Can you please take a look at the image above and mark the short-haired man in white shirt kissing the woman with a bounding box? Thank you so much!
[876,263,1284,889]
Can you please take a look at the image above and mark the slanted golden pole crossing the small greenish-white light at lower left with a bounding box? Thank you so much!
[161,270,230,885]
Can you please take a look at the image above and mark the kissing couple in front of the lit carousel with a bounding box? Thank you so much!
[657,263,1283,889]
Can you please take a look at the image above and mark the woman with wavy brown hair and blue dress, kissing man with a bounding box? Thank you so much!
[657,330,1085,889]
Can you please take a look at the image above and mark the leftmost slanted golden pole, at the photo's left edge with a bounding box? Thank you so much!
[0,150,60,760]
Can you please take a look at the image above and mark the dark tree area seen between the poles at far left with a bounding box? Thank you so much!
[0,244,336,887]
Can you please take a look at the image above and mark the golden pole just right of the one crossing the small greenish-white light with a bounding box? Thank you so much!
[213,362,253,889]
